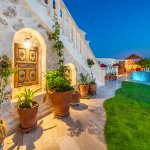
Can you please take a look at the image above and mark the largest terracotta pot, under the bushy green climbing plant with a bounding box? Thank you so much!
[48,90,73,117]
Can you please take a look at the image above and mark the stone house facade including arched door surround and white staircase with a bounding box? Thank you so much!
[0,0,104,133]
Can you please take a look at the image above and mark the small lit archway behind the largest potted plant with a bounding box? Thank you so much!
[65,63,77,85]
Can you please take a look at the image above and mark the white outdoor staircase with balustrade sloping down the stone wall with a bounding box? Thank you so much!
[25,0,104,87]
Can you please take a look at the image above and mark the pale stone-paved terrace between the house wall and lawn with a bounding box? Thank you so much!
[4,80,121,150]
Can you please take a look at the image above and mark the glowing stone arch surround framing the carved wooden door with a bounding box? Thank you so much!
[12,28,46,98]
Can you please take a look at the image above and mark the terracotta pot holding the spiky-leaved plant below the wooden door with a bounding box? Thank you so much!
[18,102,39,129]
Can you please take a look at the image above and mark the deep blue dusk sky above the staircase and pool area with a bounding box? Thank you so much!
[64,0,150,58]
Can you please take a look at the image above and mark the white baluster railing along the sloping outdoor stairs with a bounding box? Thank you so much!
[27,0,104,84]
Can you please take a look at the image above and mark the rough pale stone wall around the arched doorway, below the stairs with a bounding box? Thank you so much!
[0,0,91,132]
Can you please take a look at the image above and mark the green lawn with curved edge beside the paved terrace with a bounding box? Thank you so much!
[104,82,150,150]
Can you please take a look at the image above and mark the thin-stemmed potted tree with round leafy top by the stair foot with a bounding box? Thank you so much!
[87,59,97,95]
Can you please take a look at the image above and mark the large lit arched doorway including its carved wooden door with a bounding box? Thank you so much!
[12,28,46,98]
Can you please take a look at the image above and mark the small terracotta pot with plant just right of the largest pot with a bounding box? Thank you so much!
[71,86,80,105]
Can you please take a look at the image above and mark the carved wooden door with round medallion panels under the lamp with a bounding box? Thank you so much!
[14,44,38,87]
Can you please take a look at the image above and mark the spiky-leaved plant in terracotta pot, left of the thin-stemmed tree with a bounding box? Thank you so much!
[80,73,89,98]
